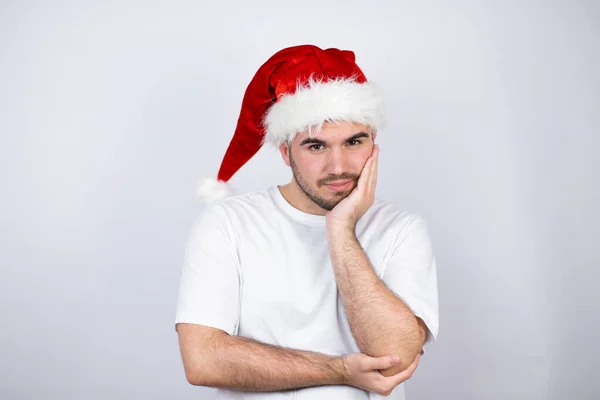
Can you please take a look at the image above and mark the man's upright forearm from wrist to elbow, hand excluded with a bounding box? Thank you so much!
[329,229,425,373]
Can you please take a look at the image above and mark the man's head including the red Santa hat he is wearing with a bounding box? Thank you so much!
[197,44,385,203]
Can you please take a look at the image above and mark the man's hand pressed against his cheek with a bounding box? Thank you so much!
[327,145,379,231]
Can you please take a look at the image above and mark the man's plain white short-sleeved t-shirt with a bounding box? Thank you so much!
[176,186,439,400]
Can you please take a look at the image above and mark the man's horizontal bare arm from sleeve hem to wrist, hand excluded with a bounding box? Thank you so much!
[177,324,346,392]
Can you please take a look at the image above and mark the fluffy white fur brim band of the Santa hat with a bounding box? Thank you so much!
[264,78,385,146]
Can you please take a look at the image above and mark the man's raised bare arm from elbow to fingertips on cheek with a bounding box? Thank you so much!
[327,145,426,376]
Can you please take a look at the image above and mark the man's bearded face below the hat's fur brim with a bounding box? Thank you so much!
[280,122,375,211]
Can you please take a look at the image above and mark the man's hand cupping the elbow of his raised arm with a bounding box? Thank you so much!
[344,353,421,396]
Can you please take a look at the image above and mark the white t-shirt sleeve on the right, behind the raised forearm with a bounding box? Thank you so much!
[382,214,439,344]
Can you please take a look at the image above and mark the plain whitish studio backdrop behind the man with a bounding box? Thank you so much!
[0,0,600,400]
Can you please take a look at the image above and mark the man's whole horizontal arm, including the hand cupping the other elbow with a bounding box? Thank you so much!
[177,323,419,396]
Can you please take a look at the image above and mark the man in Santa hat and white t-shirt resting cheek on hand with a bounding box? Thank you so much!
[176,45,439,400]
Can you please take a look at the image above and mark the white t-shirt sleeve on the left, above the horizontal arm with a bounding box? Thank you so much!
[175,205,240,335]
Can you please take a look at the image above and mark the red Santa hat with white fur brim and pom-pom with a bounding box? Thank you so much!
[197,45,384,202]
